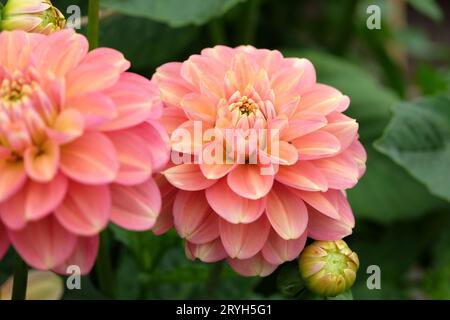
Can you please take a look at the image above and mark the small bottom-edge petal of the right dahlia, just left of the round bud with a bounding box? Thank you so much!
[261,230,307,265]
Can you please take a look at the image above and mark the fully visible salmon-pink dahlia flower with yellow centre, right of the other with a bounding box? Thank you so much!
[153,46,366,276]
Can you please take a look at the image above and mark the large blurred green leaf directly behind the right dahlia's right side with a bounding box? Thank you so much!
[287,51,443,223]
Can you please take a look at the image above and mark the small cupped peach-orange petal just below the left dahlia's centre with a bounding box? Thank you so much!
[24,140,60,182]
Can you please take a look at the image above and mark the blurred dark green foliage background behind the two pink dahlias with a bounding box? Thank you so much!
[0,0,450,299]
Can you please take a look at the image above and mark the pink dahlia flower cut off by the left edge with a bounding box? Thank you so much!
[0,30,169,273]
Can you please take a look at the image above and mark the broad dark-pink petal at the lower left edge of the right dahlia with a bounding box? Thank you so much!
[173,191,219,244]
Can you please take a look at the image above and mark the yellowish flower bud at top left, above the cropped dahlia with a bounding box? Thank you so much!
[0,0,66,34]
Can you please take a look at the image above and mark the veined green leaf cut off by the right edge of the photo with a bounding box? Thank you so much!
[376,96,450,201]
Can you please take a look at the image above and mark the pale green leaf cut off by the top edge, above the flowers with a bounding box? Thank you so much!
[101,0,244,27]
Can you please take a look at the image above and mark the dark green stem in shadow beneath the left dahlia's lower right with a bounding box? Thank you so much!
[96,230,114,298]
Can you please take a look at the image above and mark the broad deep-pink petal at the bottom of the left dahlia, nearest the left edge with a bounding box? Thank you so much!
[8,216,77,270]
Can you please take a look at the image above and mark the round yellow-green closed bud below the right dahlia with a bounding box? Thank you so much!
[299,240,359,297]
